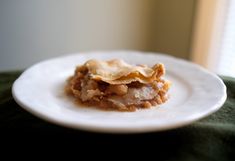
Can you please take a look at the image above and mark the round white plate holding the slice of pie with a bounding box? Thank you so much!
[12,51,226,133]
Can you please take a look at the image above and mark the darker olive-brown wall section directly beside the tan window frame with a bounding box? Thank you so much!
[149,0,196,59]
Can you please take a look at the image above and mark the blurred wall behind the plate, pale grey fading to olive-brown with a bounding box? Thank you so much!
[0,0,196,71]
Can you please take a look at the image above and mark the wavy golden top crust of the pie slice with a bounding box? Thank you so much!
[84,59,165,84]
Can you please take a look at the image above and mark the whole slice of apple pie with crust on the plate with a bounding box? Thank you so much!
[65,59,170,111]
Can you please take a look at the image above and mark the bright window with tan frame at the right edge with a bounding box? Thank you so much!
[191,0,235,77]
